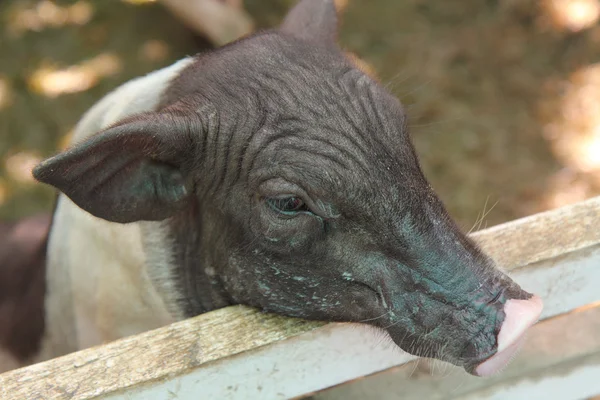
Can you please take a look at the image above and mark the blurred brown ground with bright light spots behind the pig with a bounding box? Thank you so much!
[0,0,600,230]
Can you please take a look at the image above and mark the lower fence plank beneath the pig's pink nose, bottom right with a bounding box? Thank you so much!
[313,306,600,400]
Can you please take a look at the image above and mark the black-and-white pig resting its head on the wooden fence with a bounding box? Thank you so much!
[33,0,542,376]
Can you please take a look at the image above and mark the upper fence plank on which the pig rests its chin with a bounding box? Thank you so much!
[0,198,600,399]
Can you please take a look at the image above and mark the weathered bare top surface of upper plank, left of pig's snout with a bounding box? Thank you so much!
[0,306,322,400]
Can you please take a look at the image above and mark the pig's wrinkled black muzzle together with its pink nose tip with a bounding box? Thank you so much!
[365,205,543,376]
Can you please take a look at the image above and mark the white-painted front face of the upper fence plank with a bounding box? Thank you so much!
[98,245,600,400]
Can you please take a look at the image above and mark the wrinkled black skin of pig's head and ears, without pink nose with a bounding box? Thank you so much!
[34,0,531,372]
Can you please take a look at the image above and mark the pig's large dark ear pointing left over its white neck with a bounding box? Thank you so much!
[33,114,193,223]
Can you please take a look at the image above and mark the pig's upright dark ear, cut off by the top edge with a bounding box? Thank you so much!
[281,0,337,43]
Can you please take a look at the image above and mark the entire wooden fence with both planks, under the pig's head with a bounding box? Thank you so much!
[0,198,600,400]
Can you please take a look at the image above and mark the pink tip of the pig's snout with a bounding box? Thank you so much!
[475,296,544,376]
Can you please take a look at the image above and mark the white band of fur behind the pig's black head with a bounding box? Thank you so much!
[38,59,191,361]
